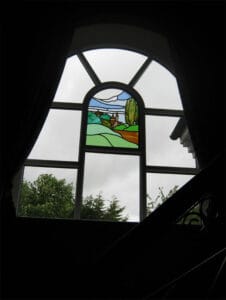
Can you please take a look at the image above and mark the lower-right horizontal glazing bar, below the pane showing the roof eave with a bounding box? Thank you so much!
[146,166,200,175]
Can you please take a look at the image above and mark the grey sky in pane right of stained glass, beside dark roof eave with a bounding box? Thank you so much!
[146,116,195,168]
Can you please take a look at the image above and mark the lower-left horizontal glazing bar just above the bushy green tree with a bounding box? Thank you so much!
[24,159,79,169]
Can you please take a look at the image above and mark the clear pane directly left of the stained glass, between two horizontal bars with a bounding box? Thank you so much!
[28,109,81,161]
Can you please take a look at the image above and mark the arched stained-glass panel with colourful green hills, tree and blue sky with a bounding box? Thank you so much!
[86,89,139,149]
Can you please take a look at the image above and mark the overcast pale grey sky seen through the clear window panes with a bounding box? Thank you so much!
[24,49,195,221]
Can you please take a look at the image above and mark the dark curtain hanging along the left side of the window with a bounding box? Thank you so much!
[1,4,73,218]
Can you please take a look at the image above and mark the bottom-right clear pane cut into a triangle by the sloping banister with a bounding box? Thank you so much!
[147,173,194,214]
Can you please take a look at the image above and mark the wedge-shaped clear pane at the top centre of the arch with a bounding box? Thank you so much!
[84,49,147,83]
